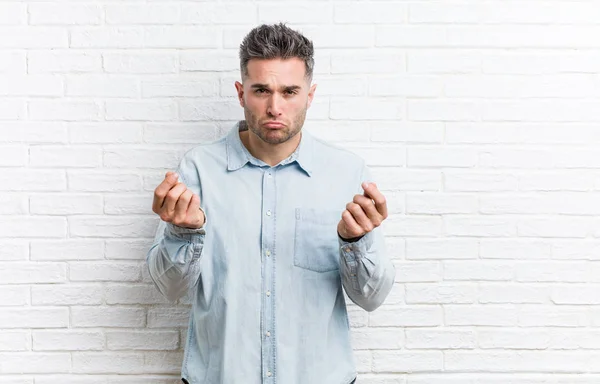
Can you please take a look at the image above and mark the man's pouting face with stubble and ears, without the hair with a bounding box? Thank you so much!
[235,58,316,144]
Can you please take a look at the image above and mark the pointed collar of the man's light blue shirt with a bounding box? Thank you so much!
[226,120,314,176]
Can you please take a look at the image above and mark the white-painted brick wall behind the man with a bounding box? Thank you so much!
[0,0,600,384]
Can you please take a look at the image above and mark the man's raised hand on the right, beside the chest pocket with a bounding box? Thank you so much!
[337,183,388,240]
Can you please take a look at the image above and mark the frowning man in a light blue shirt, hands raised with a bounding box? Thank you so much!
[147,24,395,384]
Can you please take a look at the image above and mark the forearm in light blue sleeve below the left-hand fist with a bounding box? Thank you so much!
[146,220,206,301]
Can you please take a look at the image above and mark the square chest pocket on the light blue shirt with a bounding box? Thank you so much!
[294,208,341,272]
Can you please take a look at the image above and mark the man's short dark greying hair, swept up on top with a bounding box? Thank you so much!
[240,23,315,80]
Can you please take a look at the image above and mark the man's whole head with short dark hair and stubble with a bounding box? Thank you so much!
[235,24,316,144]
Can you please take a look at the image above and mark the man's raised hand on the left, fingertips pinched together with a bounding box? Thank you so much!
[152,172,206,229]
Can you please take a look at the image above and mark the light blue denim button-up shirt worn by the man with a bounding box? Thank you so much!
[147,121,395,384]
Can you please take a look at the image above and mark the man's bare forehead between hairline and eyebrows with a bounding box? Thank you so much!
[248,57,306,83]
